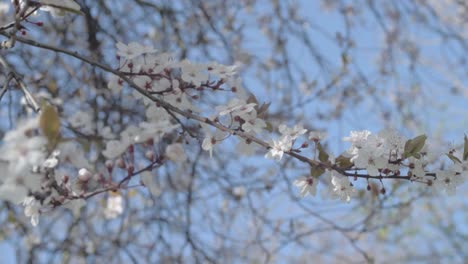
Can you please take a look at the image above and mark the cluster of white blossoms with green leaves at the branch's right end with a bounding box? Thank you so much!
[290,130,468,202]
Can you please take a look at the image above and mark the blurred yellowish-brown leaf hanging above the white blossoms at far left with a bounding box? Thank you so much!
[39,103,60,144]
